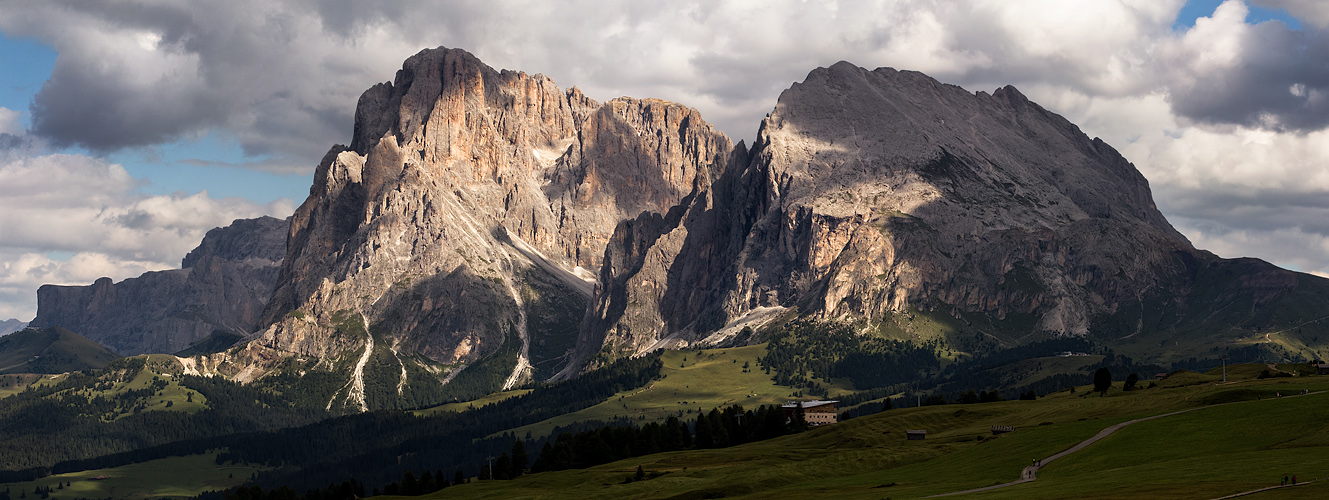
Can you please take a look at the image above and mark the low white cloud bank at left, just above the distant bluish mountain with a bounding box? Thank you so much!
[0,152,294,319]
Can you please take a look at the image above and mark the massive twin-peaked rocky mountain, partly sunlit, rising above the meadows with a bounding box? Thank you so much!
[176,48,1329,411]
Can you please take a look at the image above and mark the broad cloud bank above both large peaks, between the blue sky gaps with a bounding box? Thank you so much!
[0,0,1180,160]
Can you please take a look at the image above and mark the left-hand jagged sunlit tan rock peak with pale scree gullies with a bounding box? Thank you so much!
[219,48,732,404]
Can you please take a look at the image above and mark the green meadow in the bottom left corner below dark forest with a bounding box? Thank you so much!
[3,453,266,500]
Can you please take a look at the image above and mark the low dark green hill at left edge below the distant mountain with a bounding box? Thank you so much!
[0,327,120,374]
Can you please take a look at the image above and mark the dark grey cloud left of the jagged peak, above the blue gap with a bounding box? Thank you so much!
[0,0,404,170]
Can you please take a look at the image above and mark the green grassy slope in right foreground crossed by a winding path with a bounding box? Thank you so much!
[390,360,1329,499]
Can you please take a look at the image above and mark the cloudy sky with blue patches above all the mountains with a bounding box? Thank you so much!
[0,0,1329,320]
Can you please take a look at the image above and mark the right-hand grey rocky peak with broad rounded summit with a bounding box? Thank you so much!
[569,63,1325,374]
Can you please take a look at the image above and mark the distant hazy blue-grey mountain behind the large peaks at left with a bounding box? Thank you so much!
[32,217,288,355]
